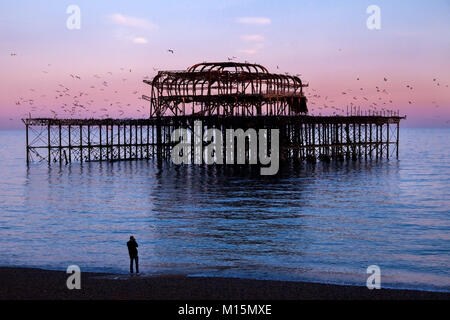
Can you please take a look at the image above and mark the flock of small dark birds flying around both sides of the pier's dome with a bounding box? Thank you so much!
[10,49,450,124]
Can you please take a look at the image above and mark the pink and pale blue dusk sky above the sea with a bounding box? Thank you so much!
[0,0,450,129]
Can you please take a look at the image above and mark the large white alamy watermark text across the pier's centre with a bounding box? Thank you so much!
[171,121,280,175]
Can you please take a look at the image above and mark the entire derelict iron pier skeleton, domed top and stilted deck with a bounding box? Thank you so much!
[23,62,404,168]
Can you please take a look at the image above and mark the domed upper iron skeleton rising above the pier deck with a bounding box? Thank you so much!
[143,62,308,118]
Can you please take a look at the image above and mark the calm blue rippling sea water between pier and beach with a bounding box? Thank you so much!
[0,129,450,291]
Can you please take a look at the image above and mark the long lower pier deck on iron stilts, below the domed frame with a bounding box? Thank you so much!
[24,115,403,164]
